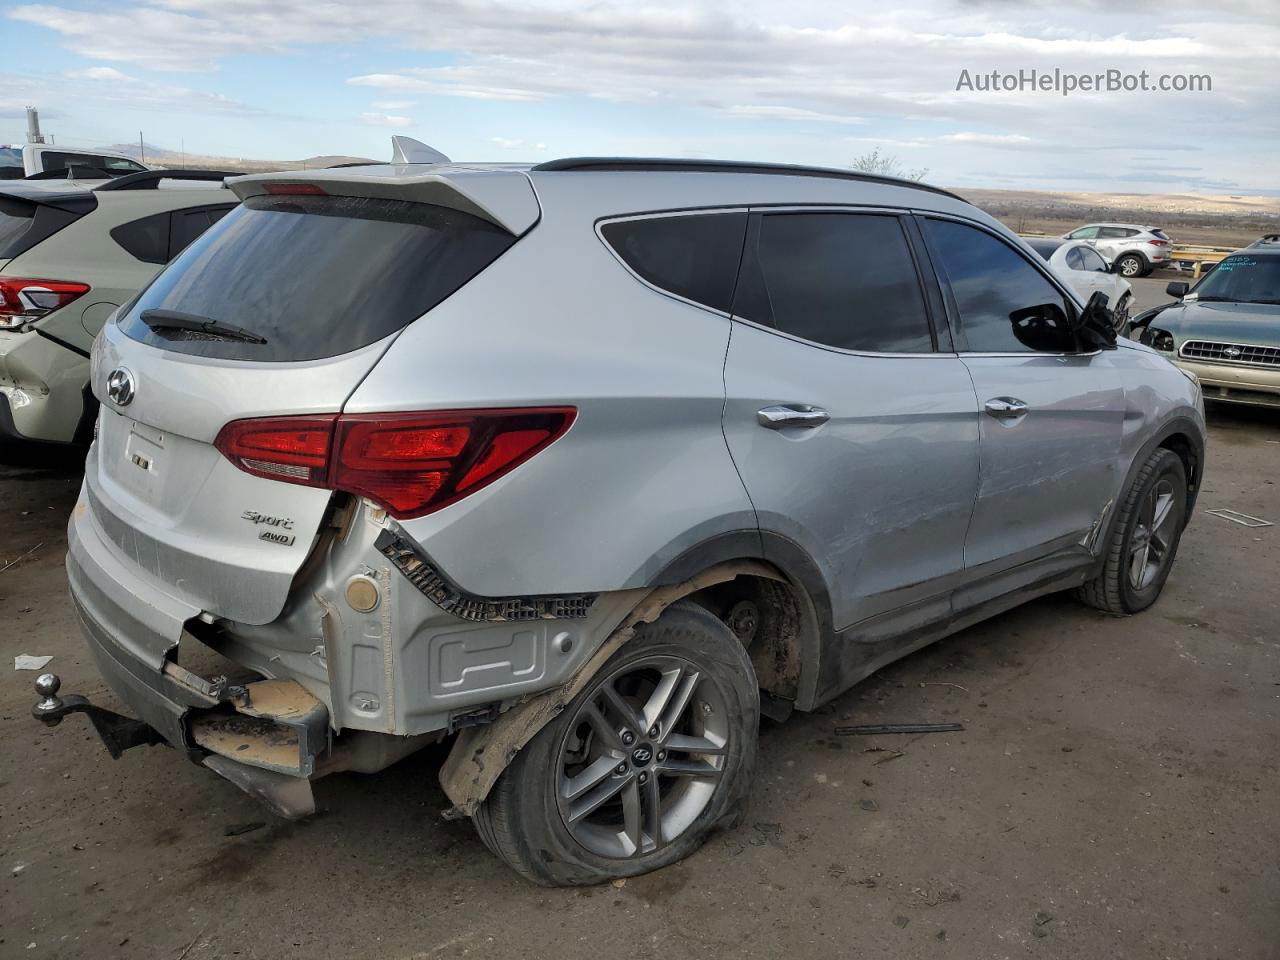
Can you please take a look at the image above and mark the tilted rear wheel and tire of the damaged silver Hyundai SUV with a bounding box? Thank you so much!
[475,602,760,886]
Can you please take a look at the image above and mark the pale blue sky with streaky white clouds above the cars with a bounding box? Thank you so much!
[0,0,1280,195]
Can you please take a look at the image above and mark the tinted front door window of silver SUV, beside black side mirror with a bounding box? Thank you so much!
[925,220,1075,353]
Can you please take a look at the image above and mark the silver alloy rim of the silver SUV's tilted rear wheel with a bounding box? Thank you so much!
[556,655,733,859]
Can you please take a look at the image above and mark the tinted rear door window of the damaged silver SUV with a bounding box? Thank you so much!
[733,214,933,353]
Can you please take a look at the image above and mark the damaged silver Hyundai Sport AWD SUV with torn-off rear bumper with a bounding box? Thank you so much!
[35,159,1204,884]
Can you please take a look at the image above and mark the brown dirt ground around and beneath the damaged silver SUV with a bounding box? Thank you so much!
[0,335,1280,960]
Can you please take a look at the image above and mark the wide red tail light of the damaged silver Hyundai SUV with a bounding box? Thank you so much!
[214,407,577,520]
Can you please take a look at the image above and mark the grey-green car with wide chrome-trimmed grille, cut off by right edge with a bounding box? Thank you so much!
[1130,243,1280,407]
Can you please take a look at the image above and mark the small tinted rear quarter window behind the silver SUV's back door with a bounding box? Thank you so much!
[600,214,746,312]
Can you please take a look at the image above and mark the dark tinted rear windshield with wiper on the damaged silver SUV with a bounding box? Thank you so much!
[120,196,516,361]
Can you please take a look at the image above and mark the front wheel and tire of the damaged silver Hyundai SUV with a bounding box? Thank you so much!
[1076,448,1187,617]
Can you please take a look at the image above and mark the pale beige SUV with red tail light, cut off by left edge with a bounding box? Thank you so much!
[0,170,239,443]
